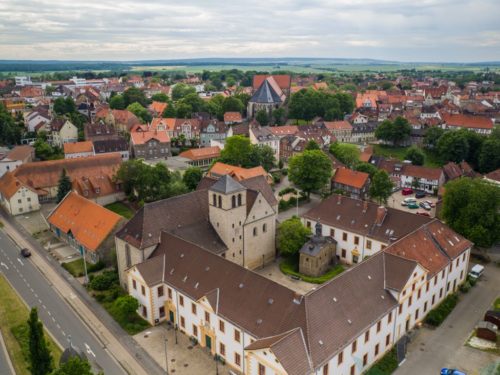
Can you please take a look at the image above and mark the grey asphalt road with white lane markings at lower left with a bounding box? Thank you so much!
[0,231,125,375]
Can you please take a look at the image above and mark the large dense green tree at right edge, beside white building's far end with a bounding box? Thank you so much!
[442,178,500,247]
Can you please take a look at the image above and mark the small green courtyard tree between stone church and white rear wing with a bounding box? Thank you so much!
[277,216,311,256]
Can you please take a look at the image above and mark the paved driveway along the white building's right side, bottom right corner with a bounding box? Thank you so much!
[394,264,500,375]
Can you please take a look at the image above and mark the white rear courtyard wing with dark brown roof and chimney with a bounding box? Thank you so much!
[301,194,431,264]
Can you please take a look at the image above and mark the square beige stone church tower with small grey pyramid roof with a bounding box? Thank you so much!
[208,175,247,265]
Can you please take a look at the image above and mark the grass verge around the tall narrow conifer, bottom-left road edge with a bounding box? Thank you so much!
[0,275,61,375]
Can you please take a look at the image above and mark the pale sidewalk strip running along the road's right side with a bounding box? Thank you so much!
[0,212,163,375]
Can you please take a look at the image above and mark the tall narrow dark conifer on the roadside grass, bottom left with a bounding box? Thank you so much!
[28,307,53,375]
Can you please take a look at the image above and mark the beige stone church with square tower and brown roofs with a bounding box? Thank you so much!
[116,175,278,288]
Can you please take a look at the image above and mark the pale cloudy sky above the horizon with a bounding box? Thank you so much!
[0,0,500,62]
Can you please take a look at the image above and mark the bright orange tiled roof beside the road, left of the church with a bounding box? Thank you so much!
[47,192,122,251]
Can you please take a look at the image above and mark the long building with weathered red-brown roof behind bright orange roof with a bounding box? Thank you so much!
[13,154,125,205]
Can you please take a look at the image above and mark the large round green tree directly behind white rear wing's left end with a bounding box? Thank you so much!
[288,150,332,196]
